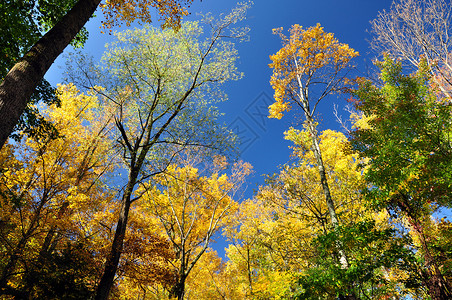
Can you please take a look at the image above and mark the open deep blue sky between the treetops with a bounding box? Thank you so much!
[46,0,391,197]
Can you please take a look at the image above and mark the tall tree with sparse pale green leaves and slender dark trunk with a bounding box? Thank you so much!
[67,4,247,299]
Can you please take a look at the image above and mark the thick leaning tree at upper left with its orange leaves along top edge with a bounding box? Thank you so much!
[0,0,196,147]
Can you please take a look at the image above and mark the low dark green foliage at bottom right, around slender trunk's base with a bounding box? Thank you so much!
[296,220,419,299]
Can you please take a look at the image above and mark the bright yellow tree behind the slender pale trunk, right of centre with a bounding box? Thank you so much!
[257,127,366,288]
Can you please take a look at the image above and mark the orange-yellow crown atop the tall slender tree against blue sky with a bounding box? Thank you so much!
[269,24,358,119]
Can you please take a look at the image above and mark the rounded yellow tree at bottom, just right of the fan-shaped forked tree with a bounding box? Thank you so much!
[224,195,305,299]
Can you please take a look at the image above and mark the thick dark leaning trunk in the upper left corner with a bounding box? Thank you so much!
[0,0,101,149]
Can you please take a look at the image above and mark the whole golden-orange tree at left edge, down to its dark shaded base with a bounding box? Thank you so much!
[0,85,113,299]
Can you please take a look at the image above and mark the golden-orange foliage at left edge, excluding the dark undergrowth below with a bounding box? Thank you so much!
[0,84,115,292]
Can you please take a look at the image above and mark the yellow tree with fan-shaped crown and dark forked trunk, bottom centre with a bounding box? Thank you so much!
[138,154,251,299]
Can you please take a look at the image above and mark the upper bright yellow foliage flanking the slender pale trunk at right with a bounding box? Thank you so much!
[280,128,365,223]
